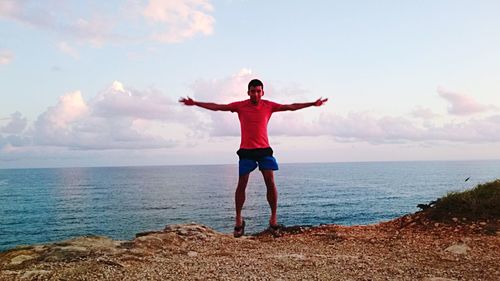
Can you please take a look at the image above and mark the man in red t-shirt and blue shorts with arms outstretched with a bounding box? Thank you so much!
[179,79,328,237]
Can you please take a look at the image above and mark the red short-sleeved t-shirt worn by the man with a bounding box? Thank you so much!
[229,99,281,149]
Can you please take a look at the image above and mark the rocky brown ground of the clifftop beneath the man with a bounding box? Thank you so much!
[0,214,500,281]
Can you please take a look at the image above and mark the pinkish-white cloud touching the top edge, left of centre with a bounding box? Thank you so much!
[143,0,215,43]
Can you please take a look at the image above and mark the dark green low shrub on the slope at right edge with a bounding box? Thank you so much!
[419,179,500,220]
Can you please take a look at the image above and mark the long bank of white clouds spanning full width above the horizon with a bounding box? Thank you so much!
[0,73,500,166]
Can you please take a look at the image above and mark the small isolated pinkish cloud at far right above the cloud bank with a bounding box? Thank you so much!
[437,87,497,115]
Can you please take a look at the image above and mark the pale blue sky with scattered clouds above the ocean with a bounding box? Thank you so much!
[0,0,500,168]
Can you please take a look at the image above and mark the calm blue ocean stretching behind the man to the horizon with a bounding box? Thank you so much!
[0,160,500,251]
